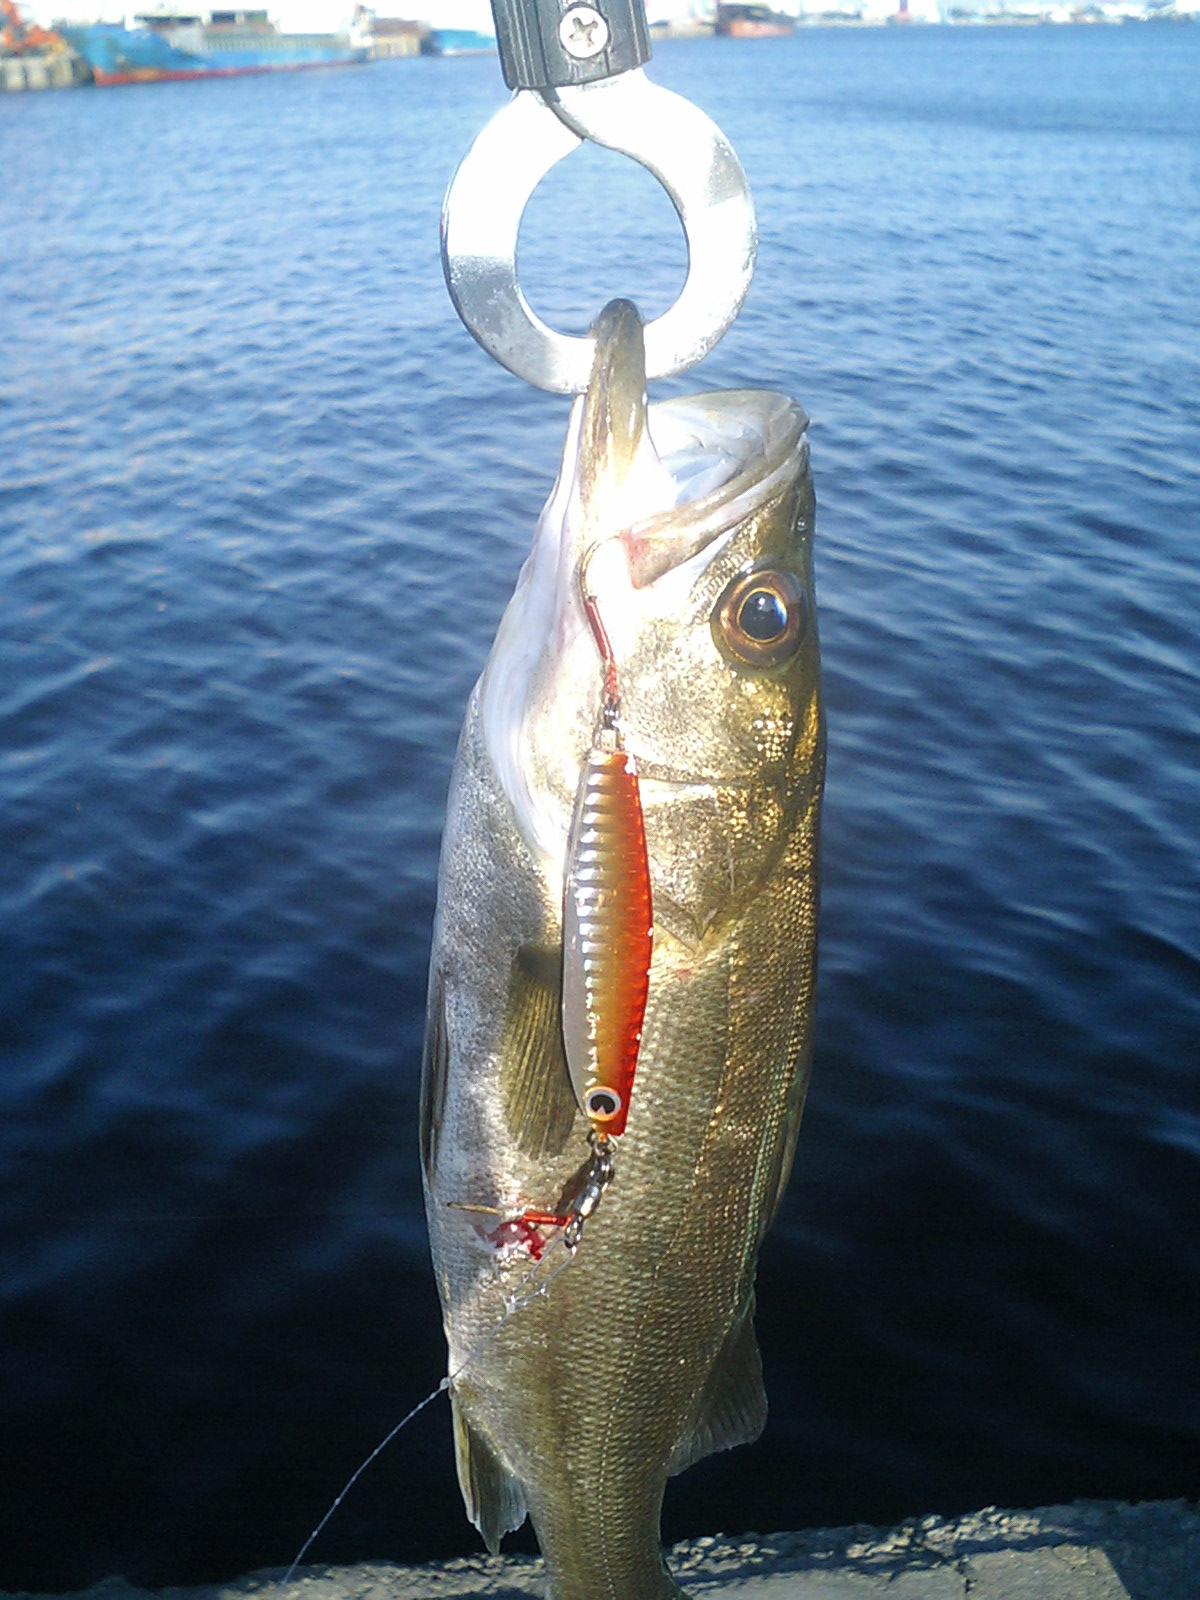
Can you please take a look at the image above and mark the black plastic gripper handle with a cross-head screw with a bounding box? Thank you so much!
[491,0,650,90]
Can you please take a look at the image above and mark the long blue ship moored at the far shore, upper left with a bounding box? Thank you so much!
[62,6,371,88]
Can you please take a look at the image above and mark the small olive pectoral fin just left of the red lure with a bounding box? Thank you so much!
[501,944,579,1155]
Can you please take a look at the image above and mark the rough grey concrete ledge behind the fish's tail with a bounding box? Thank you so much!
[0,1501,1200,1600]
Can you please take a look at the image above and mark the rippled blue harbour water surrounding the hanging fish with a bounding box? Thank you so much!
[0,26,1200,1589]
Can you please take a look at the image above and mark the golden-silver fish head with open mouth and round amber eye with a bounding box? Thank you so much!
[480,301,824,949]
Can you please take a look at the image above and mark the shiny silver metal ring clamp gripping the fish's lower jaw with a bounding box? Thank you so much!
[442,69,757,394]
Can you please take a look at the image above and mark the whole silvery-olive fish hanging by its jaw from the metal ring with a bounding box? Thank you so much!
[419,301,826,1600]
